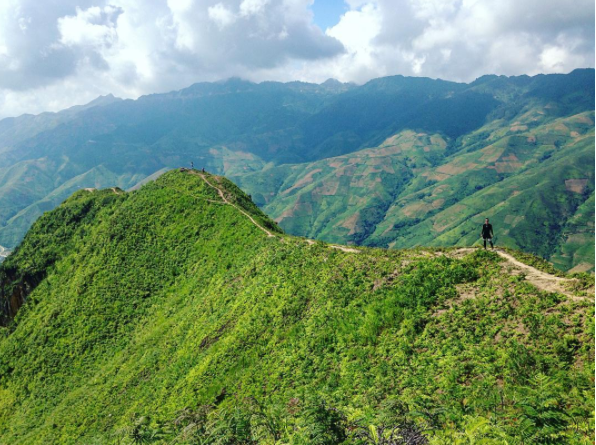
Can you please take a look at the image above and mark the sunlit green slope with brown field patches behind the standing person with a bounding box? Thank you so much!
[235,105,594,271]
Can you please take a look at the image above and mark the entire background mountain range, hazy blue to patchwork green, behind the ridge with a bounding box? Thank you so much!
[0,69,594,270]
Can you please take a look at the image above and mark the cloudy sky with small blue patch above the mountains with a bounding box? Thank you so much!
[0,0,595,118]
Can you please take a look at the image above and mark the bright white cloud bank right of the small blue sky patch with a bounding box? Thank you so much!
[297,0,594,82]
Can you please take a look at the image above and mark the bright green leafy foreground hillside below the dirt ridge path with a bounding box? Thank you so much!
[0,171,594,444]
